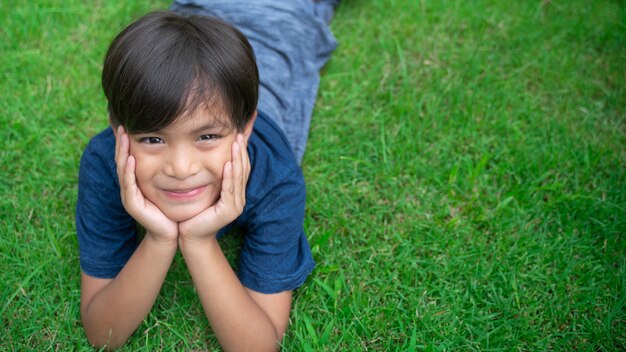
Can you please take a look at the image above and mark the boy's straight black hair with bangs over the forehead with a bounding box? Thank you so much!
[102,11,259,133]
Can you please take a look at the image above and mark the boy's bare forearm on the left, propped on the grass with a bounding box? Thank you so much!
[81,235,177,348]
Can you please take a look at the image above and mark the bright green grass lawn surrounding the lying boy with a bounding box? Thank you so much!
[0,0,626,351]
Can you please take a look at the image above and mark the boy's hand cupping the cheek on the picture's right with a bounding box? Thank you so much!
[178,134,250,241]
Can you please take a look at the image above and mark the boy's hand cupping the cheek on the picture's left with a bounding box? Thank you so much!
[115,126,178,245]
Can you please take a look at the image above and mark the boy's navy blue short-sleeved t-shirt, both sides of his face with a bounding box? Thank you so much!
[76,111,315,293]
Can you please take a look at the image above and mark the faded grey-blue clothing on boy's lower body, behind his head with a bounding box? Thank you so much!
[170,0,338,163]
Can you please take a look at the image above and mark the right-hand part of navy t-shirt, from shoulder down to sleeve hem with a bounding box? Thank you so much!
[238,115,315,294]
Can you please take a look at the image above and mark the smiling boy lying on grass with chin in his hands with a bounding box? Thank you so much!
[76,0,335,351]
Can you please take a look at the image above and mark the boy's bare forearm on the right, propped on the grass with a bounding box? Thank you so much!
[180,238,282,351]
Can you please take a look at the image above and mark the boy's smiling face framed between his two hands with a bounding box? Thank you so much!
[124,108,254,221]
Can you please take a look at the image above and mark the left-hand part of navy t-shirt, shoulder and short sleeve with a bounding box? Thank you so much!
[76,129,138,278]
